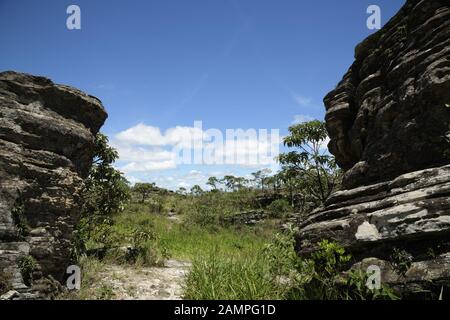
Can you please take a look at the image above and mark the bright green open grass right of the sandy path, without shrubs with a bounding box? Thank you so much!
[115,202,282,300]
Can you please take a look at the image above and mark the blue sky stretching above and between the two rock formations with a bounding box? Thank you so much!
[0,0,405,189]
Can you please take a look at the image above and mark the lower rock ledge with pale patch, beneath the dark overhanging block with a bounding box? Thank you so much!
[298,165,450,297]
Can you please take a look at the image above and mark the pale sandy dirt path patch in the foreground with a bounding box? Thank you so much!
[97,260,190,300]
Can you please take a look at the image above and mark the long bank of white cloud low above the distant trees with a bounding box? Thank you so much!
[111,122,282,173]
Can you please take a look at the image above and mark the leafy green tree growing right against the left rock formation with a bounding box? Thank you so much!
[76,133,130,253]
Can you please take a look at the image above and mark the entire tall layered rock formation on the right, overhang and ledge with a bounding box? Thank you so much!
[297,0,450,297]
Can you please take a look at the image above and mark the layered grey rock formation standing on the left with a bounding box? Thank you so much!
[0,72,107,298]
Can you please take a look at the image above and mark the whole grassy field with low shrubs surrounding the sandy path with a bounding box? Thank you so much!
[66,194,395,300]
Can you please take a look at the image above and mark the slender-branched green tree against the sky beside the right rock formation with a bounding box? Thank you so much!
[279,120,341,204]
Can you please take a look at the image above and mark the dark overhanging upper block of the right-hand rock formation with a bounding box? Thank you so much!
[325,0,450,188]
